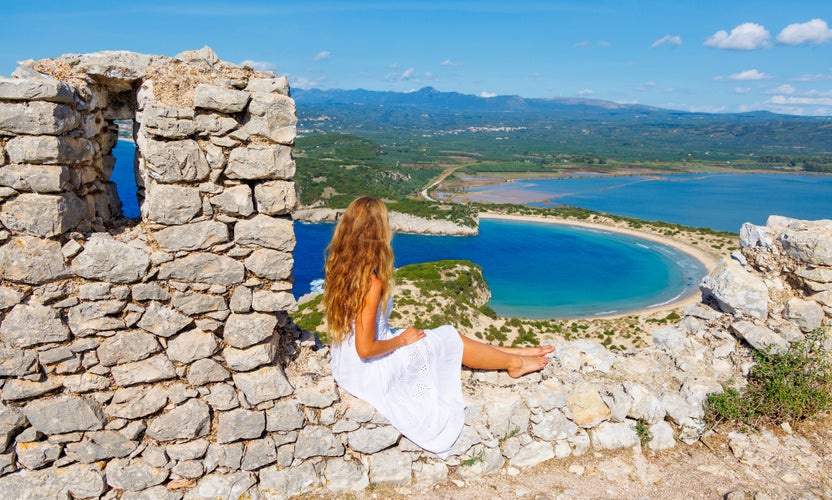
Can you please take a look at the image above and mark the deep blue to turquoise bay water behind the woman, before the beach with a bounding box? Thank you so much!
[294,219,705,319]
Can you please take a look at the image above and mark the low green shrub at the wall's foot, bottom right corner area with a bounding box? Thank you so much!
[705,330,832,426]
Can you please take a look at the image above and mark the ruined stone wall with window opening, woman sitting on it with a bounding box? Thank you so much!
[0,49,832,499]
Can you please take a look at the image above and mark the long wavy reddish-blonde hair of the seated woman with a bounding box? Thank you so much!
[323,197,393,344]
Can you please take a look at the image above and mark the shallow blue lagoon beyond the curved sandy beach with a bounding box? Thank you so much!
[462,174,832,232]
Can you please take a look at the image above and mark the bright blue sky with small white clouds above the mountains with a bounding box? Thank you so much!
[0,0,832,116]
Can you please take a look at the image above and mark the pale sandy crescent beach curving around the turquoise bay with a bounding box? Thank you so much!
[479,212,723,319]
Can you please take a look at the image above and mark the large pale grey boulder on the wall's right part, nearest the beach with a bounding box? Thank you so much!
[699,260,768,319]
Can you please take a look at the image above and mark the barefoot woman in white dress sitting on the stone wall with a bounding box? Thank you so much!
[324,197,552,458]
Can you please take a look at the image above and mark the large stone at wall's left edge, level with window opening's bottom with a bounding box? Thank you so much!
[0,193,86,238]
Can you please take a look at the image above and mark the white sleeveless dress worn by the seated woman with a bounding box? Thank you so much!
[330,299,465,459]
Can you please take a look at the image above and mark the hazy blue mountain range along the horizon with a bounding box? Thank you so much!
[292,87,832,159]
